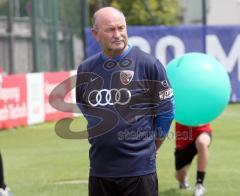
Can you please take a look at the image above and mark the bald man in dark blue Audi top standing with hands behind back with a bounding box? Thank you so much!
[76,7,174,196]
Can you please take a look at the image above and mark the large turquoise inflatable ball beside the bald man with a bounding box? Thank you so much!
[166,53,231,126]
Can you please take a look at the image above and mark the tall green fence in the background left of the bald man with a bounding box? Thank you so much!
[0,0,84,74]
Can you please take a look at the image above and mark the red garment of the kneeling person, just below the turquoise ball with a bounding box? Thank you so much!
[175,122,212,150]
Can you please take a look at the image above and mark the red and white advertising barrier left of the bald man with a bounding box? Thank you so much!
[0,72,74,129]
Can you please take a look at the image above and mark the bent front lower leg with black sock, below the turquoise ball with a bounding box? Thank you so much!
[195,133,211,184]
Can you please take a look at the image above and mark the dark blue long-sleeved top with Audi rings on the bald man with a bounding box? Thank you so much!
[76,47,174,177]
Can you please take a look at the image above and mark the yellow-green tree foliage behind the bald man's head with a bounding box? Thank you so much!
[90,0,181,25]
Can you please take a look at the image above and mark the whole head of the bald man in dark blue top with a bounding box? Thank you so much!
[92,7,128,57]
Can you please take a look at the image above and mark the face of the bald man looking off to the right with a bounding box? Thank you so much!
[93,15,128,57]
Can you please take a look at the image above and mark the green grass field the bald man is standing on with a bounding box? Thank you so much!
[0,104,240,196]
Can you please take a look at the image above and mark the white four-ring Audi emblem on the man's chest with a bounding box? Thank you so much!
[88,88,131,107]
